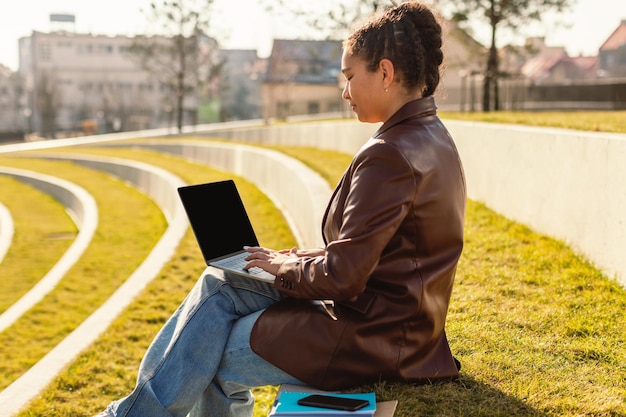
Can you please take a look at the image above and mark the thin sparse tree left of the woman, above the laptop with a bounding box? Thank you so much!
[128,0,221,132]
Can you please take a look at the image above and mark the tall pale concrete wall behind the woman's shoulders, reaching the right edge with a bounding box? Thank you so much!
[203,120,626,285]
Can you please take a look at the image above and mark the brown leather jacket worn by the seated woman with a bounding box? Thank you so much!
[251,97,466,390]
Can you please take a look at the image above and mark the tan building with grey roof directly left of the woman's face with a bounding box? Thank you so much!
[261,39,343,119]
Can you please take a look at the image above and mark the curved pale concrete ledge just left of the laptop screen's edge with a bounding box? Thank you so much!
[0,155,187,415]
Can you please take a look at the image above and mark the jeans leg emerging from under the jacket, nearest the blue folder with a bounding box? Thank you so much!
[189,311,304,417]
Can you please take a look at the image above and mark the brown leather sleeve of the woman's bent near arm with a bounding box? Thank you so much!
[274,140,416,301]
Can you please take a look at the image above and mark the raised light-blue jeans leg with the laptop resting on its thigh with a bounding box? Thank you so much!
[105,268,282,417]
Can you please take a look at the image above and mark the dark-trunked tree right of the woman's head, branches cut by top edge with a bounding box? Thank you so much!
[438,0,575,111]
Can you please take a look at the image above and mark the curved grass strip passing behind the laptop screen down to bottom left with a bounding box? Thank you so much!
[11,149,295,417]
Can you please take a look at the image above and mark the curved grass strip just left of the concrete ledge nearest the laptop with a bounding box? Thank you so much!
[0,158,165,389]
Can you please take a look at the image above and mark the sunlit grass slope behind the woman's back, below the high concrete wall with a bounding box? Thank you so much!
[274,142,626,417]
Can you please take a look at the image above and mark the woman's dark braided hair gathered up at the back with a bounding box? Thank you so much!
[343,2,443,97]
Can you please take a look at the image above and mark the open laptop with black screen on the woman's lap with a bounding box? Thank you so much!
[178,180,275,283]
